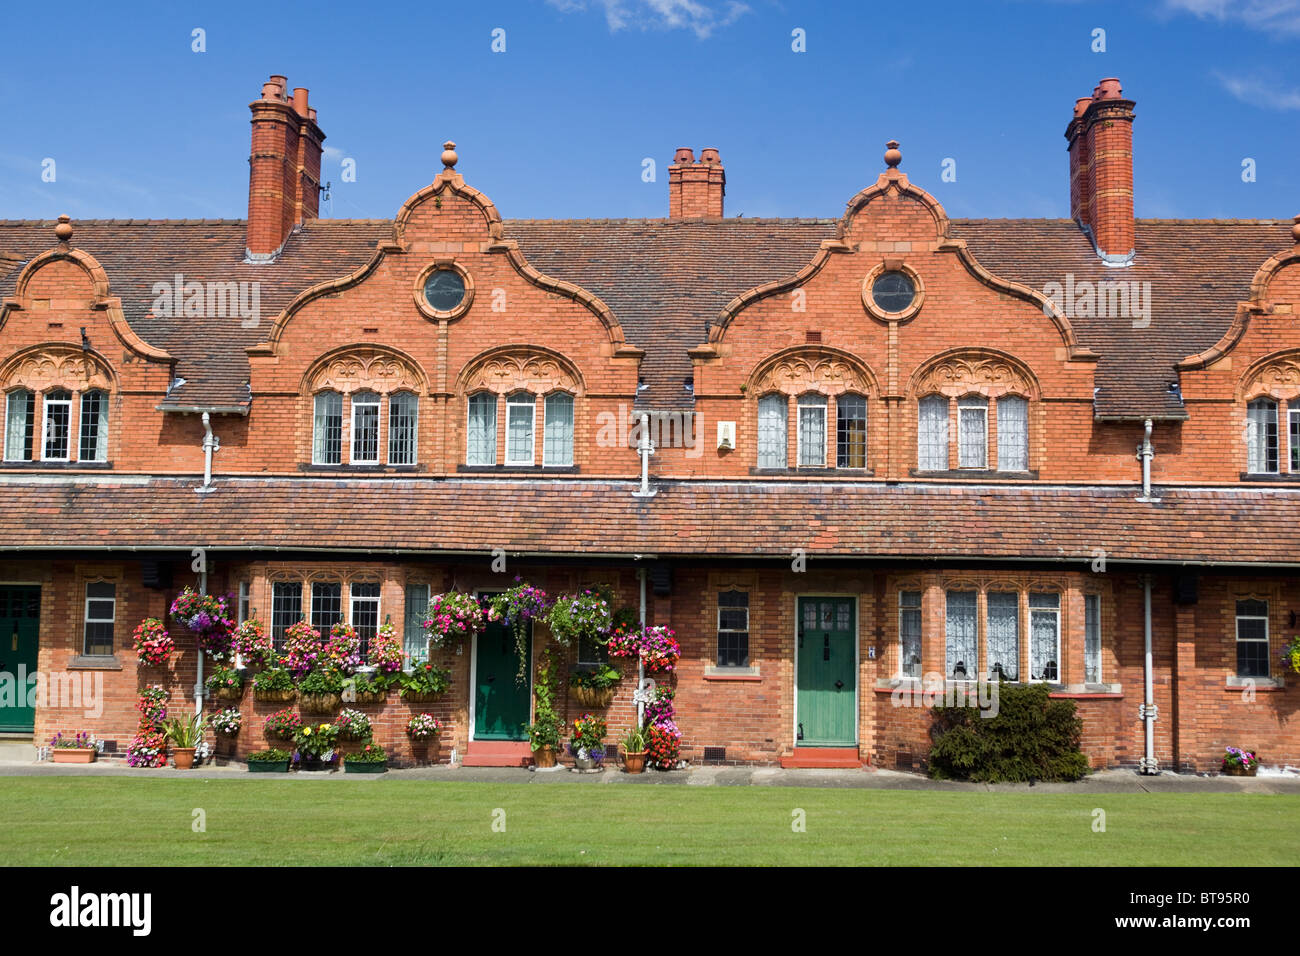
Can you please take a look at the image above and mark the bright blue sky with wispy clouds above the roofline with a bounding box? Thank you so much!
[0,0,1300,219]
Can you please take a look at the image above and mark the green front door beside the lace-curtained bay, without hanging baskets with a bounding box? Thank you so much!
[794,597,858,747]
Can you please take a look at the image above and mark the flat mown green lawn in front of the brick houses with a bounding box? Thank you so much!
[0,777,1300,866]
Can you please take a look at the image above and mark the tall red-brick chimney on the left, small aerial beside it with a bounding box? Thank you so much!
[247,75,325,261]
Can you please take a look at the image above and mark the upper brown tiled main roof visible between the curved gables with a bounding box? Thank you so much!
[0,219,1292,418]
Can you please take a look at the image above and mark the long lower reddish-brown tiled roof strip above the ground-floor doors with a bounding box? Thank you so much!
[0,476,1300,568]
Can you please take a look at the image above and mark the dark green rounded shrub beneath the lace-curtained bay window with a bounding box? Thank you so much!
[930,683,1088,783]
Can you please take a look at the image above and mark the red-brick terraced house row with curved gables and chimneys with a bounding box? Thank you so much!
[0,77,1300,770]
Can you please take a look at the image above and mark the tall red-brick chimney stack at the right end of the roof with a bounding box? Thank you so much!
[1065,77,1135,264]
